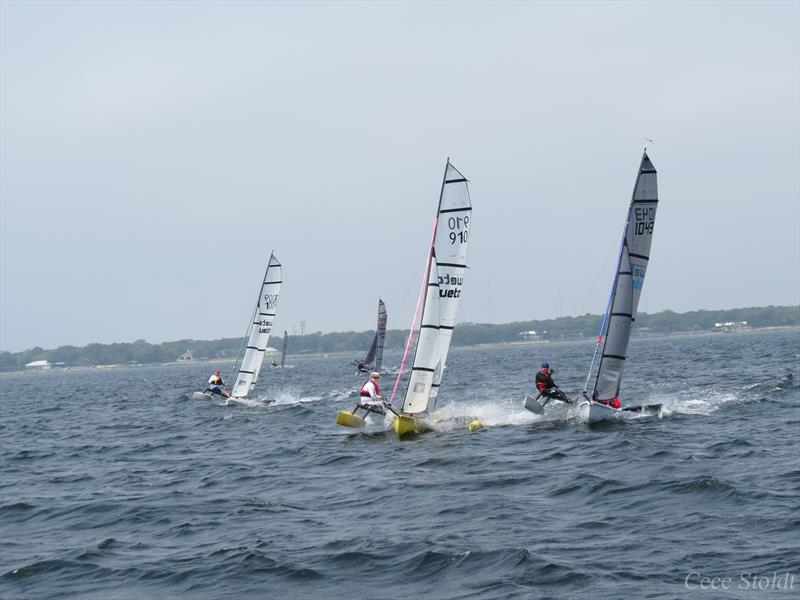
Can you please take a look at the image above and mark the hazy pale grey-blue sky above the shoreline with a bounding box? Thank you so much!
[0,1,800,351]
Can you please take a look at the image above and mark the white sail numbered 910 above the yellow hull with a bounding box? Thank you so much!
[402,160,472,414]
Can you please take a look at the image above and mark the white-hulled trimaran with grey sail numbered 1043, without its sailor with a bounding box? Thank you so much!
[525,148,662,423]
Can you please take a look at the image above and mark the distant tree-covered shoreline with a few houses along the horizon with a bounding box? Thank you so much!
[0,306,800,371]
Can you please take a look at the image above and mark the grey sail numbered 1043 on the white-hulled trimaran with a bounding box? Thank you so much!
[592,151,658,400]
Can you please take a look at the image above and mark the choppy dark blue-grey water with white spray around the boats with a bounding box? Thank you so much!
[0,330,800,599]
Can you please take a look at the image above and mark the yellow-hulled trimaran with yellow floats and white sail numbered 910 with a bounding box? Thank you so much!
[336,159,481,436]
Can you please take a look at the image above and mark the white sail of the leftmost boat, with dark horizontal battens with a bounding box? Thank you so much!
[231,254,283,398]
